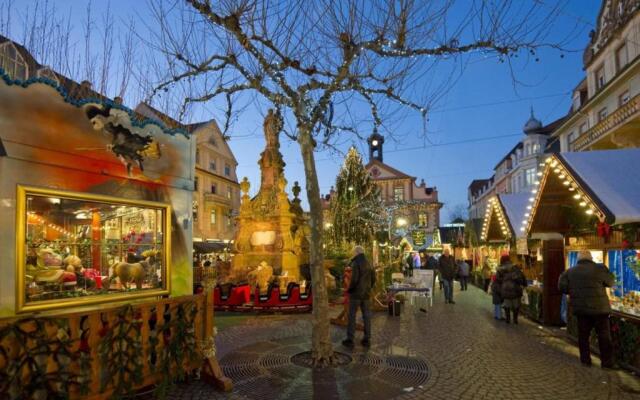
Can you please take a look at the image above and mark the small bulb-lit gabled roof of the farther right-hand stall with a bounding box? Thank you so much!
[480,193,533,241]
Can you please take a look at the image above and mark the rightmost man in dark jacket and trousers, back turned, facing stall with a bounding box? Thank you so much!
[558,251,615,368]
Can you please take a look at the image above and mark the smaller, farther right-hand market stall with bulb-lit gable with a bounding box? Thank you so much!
[476,193,543,321]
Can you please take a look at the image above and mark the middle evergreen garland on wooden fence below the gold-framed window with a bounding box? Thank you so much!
[98,306,144,399]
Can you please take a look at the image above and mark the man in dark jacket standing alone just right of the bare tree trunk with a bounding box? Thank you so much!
[342,246,376,347]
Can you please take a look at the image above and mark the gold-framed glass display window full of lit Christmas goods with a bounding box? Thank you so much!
[16,186,171,312]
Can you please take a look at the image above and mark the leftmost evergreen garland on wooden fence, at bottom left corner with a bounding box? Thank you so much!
[0,318,91,399]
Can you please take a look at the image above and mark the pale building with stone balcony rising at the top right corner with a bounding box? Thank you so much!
[553,0,640,152]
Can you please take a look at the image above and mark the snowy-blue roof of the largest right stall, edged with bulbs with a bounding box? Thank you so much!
[519,149,640,234]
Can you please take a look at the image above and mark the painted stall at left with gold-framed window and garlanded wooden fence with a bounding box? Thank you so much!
[0,70,230,399]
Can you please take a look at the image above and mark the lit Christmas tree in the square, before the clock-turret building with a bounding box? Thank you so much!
[330,147,382,245]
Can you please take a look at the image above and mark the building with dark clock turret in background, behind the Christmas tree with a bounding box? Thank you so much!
[365,134,442,244]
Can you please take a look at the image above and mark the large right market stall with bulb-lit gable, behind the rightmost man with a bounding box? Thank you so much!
[521,149,640,368]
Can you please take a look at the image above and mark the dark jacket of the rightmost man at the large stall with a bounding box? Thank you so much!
[558,260,615,315]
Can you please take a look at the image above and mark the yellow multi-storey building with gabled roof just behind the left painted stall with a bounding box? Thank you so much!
[136,103,240,244]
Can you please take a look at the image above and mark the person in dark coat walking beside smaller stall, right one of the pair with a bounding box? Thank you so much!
[496,255,527,325]
